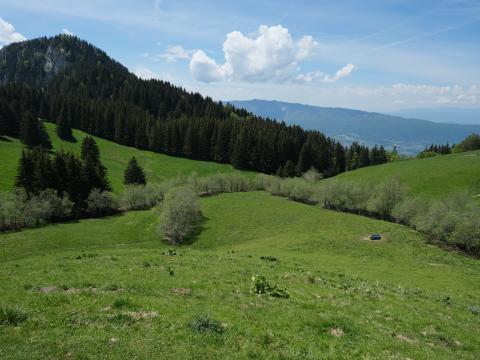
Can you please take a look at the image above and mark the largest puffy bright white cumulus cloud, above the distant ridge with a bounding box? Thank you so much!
[190,25,355,82]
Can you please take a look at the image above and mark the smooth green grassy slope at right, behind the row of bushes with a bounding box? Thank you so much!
[326,151,480,197]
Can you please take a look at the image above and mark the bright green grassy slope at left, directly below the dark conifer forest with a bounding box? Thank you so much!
[0,123,246,192]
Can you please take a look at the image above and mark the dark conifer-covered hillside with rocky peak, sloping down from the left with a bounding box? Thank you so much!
[0,35,384,176]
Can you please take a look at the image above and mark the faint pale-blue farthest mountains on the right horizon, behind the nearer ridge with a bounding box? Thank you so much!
[388,107,480,125]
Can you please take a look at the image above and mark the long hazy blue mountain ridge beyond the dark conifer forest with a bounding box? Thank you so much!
[227,99,480,154]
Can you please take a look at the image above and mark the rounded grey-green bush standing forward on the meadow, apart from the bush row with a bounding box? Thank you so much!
[158,186,202,244]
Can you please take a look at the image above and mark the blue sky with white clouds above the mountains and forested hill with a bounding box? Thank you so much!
[0,0,480,111]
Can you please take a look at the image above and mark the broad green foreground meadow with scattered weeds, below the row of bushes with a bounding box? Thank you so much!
[0,193,480,359]
